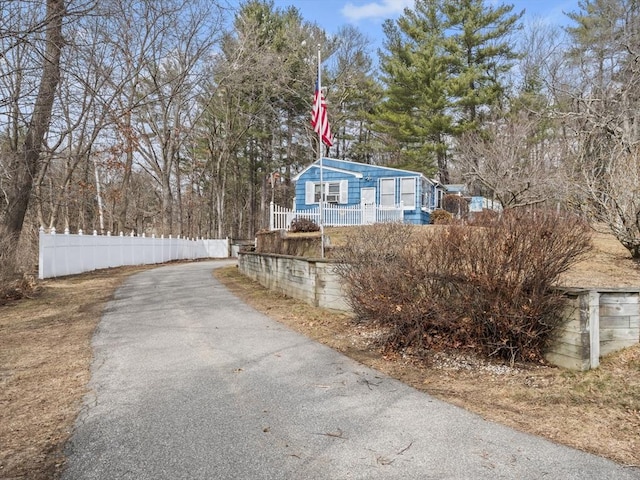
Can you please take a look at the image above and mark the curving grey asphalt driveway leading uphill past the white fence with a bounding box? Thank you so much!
[63,261,640,480]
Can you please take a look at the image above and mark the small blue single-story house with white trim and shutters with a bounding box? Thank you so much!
[293,158,444,225]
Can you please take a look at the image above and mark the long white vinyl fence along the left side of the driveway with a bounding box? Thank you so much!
[38,228,230,278]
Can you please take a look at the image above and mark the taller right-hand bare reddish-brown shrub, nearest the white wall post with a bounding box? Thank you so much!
[430,210,591,361]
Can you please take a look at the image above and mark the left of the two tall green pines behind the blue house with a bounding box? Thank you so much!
[374,0,452,178]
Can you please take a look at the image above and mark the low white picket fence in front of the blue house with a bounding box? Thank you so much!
[269,203,404,230]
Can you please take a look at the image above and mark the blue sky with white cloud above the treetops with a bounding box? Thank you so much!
[274,0,578,48]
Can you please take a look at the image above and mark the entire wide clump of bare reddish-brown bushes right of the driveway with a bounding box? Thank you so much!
[338,211,591,361]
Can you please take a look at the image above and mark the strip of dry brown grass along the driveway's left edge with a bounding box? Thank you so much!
[0,268,151,480]
